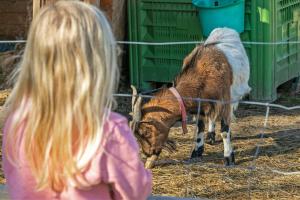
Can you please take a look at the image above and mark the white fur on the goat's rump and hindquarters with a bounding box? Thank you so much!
[204,28,251,114]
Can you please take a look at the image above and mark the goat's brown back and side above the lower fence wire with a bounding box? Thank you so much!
[176,45,232,100]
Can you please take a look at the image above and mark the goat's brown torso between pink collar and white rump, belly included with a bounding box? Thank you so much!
[175,45,233,118]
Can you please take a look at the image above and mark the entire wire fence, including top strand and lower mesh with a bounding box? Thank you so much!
[0,40,300,199]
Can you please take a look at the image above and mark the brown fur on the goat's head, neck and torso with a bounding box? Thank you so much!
[137,45,233,156]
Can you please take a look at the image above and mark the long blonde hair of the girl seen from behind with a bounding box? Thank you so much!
[6,1,119,191]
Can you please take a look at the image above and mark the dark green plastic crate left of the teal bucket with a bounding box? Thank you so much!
[128,0,202,89]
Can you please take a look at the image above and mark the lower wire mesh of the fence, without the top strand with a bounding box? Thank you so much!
[114,92,300,199]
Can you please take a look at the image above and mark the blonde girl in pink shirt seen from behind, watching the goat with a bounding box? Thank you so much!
[2,1,151,200]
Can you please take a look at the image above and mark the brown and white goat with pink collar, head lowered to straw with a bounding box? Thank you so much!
[131,28,250,168]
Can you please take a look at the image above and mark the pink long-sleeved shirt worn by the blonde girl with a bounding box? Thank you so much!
[2,113,152,200]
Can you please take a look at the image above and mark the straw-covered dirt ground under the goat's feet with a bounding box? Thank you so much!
[0,88,300,199]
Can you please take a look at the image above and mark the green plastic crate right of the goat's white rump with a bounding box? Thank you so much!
[247,0,300,100]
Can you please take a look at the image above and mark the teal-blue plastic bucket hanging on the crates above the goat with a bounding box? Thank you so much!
[193,0,245,36]
